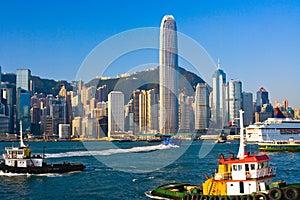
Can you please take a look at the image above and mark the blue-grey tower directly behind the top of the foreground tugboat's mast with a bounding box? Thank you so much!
[243,92,254,126]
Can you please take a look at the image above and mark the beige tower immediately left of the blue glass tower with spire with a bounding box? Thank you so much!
[195,83,210,130]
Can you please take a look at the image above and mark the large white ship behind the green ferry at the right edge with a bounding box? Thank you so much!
[246,118,300,142]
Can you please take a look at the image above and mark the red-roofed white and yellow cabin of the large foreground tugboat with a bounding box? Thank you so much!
[203,152,275,195]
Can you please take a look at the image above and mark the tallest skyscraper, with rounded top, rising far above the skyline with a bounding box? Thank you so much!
[159,15,178,134]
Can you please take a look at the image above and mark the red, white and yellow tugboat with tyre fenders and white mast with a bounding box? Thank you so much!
[145,110,300,200]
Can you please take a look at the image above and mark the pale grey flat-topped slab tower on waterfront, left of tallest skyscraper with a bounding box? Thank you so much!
[108,91,125,137]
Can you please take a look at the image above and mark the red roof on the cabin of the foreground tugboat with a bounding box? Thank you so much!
[219,152,271,164]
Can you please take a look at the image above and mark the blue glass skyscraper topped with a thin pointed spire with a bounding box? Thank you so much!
[212,60,226,128]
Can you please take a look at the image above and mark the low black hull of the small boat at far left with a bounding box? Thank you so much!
[0,163,85,174]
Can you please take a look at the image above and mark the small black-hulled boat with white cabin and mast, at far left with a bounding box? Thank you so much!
[0,121,85,174]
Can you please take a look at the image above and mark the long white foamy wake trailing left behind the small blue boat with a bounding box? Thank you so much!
[46,144,179,158]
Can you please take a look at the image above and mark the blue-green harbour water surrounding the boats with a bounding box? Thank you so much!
[0,141,300,200]
